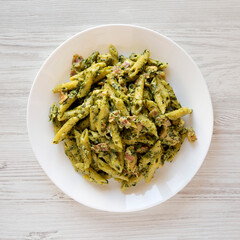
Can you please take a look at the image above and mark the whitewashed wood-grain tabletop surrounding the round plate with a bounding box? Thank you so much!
[0,0,240,240]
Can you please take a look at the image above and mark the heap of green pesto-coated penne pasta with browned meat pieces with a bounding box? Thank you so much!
[49,45,197,191]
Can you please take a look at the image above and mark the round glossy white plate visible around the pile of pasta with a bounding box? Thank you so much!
[27,25,213,212]
